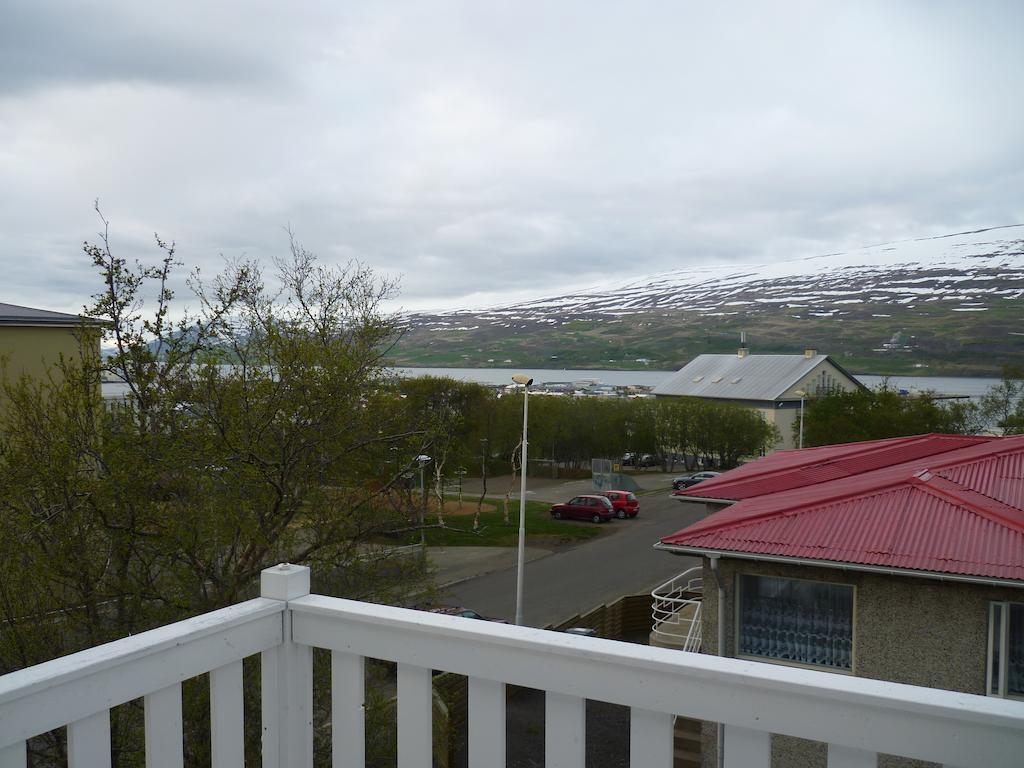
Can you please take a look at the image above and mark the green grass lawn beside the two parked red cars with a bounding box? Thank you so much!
[427,499,603,547]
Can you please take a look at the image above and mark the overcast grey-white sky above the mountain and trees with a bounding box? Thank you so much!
[0,0,1024,311]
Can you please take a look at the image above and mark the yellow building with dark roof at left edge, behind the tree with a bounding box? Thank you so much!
[0,303,100,417]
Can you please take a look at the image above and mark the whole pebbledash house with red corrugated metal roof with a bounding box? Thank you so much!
[655,434,1024,766]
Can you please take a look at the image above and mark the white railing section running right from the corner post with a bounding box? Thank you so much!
[290,595,1024,768]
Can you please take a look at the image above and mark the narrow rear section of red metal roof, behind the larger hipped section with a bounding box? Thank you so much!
[678,434,993,501]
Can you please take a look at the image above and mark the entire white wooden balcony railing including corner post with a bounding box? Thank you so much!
[0,565,1024,768]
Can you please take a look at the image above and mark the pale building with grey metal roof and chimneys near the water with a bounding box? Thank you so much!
[653,346,864,451]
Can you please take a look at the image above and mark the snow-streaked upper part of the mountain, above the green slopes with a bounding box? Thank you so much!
[410,224,1024,330]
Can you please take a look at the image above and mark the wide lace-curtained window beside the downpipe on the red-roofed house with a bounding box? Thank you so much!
[737,573,853,671]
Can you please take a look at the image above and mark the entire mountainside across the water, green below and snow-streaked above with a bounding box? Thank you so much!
[394,225,1024,376]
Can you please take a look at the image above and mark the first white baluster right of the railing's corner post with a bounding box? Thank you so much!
[331,650,367,768]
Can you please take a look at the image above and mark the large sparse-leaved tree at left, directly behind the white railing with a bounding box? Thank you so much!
[0,222,428,765]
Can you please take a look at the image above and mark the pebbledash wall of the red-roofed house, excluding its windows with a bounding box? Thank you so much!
[701,558,1024,768]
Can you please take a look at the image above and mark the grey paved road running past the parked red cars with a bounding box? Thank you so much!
[447,490,703,627]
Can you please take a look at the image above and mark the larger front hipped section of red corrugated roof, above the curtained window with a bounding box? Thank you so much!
[662,435,1024,581]
